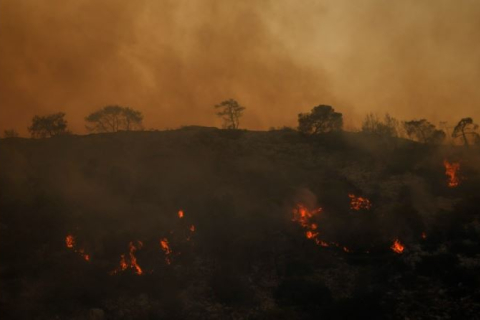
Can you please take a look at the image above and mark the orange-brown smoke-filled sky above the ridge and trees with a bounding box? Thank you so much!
[0,0,480,135]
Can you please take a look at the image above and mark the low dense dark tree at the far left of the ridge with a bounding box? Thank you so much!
[28,112,69,138]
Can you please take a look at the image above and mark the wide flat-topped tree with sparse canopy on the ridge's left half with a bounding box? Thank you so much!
[85,106,143,132]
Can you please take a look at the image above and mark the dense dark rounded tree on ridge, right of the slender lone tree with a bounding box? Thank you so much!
[298,105,343,134]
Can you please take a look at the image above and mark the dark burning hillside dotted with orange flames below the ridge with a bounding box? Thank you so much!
[0,127,480,319]
